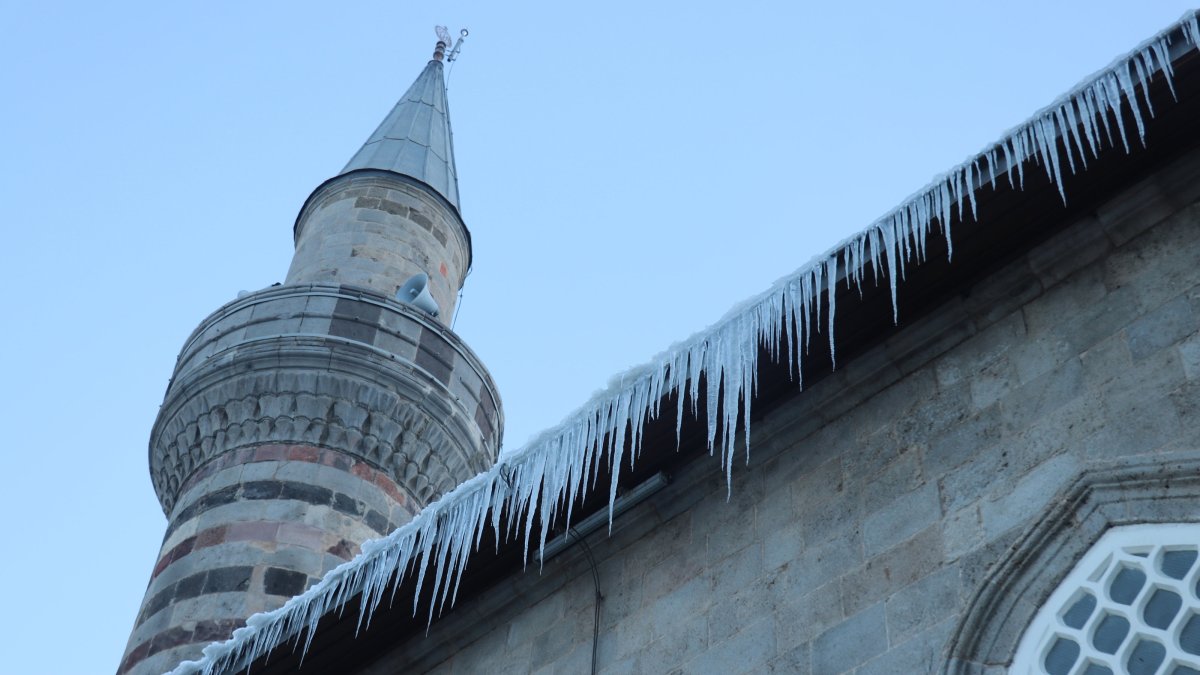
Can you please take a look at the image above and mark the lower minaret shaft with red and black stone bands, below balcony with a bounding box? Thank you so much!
[120,446,416,673]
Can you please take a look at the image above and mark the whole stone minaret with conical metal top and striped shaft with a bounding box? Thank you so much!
[119,36,503,675]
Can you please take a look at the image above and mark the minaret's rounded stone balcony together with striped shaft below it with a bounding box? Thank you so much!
[120,285,503,675]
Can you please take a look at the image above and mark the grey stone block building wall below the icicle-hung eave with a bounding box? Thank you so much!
[368,148,1200,675]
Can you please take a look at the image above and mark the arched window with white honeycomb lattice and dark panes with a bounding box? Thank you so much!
[1009,524,1200,675]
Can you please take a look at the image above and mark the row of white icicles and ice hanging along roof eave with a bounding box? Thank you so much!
[166,12,1200,675]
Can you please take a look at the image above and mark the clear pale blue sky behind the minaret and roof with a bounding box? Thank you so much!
[0,0,1187,674]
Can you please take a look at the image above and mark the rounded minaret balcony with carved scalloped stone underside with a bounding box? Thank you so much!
[150,286,503,513]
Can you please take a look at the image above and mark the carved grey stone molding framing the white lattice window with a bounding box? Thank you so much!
[943,452,1200,675]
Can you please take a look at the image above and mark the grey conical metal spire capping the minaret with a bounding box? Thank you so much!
[342,58,458,210]
